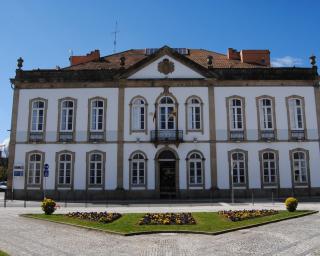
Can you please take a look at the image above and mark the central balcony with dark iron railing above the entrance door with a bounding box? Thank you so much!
[151,130,183,144]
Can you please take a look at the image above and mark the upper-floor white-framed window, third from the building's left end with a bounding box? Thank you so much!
[90,99,104,131]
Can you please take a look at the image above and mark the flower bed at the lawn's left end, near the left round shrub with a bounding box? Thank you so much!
[66,212,121,223]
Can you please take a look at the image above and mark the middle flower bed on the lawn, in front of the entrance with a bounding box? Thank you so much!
[139,213,196,225]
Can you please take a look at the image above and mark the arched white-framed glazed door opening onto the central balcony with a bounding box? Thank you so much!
[159,96,177,130]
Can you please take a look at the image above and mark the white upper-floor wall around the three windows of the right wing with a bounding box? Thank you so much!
[214,86,318,140]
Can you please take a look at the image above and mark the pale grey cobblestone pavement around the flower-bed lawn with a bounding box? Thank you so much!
[0,203,320,256]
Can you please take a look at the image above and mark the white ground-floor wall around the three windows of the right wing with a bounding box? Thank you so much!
[217,142,320,189]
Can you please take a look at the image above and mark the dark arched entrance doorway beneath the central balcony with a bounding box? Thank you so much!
[155,148,179,199]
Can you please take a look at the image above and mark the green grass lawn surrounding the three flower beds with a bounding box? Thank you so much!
[22,211,312,235]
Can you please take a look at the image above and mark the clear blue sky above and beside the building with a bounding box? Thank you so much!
[0,0,320,144]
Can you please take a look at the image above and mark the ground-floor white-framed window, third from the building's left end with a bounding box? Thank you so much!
[89,153,103,185]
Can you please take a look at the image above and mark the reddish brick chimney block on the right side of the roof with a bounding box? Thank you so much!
[228,48,270,67]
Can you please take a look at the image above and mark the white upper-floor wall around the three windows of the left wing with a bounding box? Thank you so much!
[17,88,118,142]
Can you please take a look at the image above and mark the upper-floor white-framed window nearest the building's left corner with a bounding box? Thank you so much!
[31,100,45,132]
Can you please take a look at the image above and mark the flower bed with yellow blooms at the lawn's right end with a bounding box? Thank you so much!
[218,209,278,221]
